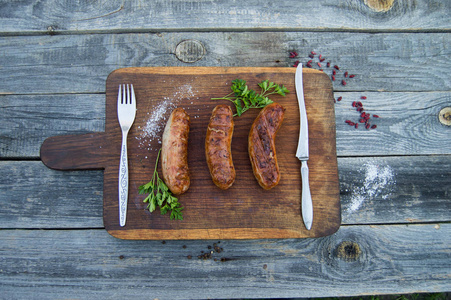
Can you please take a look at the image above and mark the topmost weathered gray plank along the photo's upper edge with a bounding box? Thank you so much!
[0,0,451,33]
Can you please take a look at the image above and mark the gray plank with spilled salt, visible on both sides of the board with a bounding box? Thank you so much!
[0,156,451,228]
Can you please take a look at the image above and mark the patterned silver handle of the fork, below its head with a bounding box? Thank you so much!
[119,132,128,226]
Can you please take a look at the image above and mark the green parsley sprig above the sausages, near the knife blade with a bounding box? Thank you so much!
[211,79,290,117]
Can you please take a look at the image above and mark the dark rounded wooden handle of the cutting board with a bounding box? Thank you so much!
[41,132,108,170]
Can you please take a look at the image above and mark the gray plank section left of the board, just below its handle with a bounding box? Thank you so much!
[0,161,103,228]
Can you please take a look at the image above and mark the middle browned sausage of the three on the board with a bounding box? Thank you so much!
[205,105,236,190]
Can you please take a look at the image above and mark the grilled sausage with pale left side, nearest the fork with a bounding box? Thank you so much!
[161,108,190,195]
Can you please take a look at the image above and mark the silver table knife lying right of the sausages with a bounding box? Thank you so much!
[294,64,313,230]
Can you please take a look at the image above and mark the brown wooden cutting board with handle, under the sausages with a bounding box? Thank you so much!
[41,67,341,240]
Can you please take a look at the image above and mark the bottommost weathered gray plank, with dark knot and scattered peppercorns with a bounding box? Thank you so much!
[0,224,451,299]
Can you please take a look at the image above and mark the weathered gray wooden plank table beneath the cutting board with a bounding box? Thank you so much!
[0,0,451,299]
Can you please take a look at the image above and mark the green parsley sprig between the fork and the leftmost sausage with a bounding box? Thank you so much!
[138,149,183,220]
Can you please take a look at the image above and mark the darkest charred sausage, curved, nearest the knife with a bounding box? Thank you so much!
[248,103,285,190]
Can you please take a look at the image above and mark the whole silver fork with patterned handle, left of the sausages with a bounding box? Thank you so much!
[117,84,136,226]
